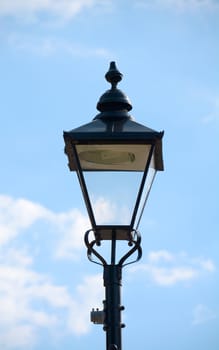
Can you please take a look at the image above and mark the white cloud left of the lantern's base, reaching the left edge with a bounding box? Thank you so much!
[0,195,90,260]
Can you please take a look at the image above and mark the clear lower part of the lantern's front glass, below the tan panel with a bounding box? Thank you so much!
[84,171,143,225]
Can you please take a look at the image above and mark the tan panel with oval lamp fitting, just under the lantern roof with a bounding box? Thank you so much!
[76,144,151,171]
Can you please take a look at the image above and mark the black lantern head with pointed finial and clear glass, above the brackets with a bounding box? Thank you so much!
[64,62,163,239]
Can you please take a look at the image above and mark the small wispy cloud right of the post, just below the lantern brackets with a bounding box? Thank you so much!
[130,250,215,286]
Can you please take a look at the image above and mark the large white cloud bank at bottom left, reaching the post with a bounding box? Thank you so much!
[0,252,103,349]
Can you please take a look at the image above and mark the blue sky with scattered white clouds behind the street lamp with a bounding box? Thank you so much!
[0,0,219,350]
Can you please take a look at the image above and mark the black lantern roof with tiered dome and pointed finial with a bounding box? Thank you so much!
[64,62,164,170]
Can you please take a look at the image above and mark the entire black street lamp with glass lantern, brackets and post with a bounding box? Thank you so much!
[64,62,163,350]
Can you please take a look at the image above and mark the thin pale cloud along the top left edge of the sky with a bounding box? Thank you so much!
[0,0,110,21]
